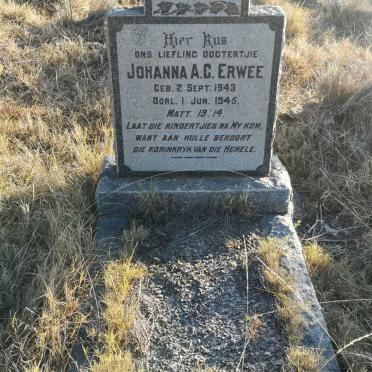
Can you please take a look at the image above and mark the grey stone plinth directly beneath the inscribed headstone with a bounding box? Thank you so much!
[96,156,292,217]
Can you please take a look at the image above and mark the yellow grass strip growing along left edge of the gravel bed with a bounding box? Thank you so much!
[91,223,149,372]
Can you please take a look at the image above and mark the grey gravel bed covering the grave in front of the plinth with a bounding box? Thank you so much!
[135,217,287,371]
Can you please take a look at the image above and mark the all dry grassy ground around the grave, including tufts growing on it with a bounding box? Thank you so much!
[0,0,372,371]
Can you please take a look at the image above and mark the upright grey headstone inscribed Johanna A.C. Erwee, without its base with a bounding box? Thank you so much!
[107,0,285,176]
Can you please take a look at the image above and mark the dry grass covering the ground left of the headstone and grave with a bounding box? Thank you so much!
[0,0,112,371]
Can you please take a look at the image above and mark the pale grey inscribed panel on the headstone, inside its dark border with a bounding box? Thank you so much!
[117,24,275,171]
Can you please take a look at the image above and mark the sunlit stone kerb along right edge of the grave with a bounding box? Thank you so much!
[261,214,340,372]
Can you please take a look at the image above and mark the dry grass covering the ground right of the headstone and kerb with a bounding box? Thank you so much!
[266,0,372,371]
